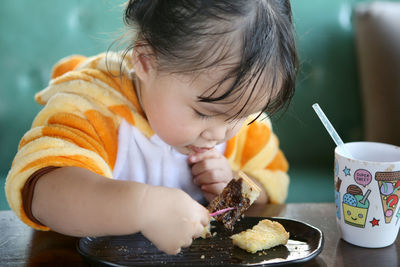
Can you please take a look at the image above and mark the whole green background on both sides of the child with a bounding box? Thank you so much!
[0,0,396,209]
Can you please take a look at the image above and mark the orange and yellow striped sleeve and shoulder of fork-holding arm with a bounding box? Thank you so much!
[5,52,153,230]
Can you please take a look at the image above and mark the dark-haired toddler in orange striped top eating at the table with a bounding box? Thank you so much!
[6,0,297,254]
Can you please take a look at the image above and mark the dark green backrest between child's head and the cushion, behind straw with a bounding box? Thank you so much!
[275,0,363,171]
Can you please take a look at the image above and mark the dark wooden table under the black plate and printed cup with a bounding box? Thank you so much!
[0,203,400,267]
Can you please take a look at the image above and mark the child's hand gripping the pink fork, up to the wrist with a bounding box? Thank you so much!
[141,186,210,254]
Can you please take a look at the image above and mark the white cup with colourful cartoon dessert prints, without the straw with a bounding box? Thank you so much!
[334,142,400,248]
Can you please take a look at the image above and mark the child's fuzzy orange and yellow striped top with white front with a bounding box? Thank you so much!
[5,52,289,230]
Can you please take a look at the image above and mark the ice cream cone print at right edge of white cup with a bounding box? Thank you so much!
[375,171,400,223]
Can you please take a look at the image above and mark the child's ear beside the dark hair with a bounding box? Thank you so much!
[132,46,156,81]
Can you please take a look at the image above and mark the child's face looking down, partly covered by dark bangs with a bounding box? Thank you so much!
[140,65,266,155]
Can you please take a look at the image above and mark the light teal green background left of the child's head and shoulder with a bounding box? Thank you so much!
[0,0,124,178]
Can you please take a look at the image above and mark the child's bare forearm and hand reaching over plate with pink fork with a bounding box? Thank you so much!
[32,167,209,254]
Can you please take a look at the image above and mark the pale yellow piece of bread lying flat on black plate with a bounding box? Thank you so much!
[231,219,289,253]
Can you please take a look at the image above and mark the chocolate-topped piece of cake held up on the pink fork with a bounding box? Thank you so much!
[207,172,261,231]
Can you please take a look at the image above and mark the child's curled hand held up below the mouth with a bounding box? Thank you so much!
[188,148,233,201]
